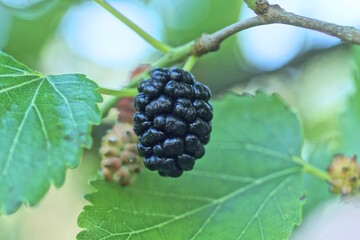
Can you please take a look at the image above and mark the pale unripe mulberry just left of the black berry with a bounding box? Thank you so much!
[100,122,143,186]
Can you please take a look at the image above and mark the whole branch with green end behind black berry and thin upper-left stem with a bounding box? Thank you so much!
[95,0,360,114]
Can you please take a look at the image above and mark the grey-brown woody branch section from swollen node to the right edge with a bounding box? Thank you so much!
[191,1,360,56]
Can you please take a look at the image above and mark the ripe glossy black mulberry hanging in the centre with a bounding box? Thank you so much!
[133,68,213,177]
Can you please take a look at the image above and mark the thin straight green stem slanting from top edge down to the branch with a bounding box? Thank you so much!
[94,0,173,53]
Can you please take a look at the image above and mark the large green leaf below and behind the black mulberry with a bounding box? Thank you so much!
[77,94,303,239]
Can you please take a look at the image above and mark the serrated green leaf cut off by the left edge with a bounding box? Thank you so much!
[0,52,101,214]
